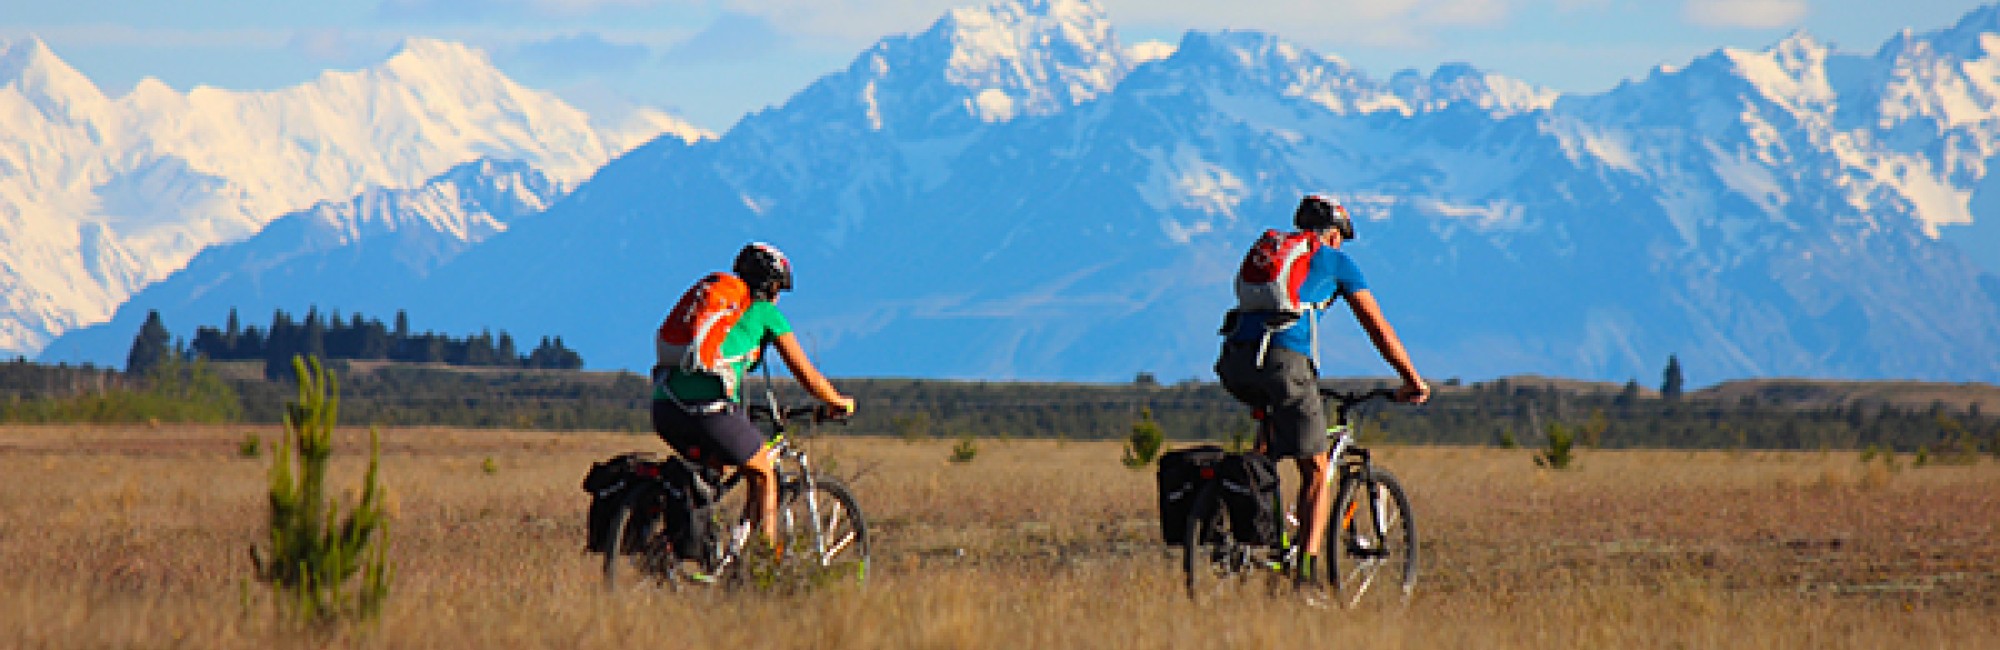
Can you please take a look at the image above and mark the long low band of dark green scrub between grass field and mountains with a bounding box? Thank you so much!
[0,352,2000,454]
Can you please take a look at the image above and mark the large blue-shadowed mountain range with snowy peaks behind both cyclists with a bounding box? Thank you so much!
[35,0,2000,382]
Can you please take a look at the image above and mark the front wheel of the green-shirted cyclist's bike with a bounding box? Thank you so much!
[778,478,872,584]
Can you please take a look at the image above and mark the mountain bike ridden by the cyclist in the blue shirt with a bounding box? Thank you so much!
[1182,388,1418,608]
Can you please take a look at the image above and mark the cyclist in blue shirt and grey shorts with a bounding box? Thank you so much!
[1216,194,1430,582]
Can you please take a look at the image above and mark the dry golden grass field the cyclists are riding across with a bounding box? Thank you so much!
[0,426,2000,650]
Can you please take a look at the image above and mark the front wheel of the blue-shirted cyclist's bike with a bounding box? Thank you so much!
[1322,468,1422,608]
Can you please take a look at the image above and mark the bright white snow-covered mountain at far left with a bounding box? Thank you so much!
[0,40,706,354]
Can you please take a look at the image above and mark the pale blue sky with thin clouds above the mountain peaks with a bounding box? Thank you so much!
[0,0,1982,130]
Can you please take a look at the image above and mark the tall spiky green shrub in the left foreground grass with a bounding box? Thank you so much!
[250,358,390,622]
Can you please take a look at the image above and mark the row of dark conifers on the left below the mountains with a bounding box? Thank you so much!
[126,308,584,378]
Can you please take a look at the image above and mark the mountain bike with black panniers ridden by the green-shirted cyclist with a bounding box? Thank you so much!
[600,398,868,588]
